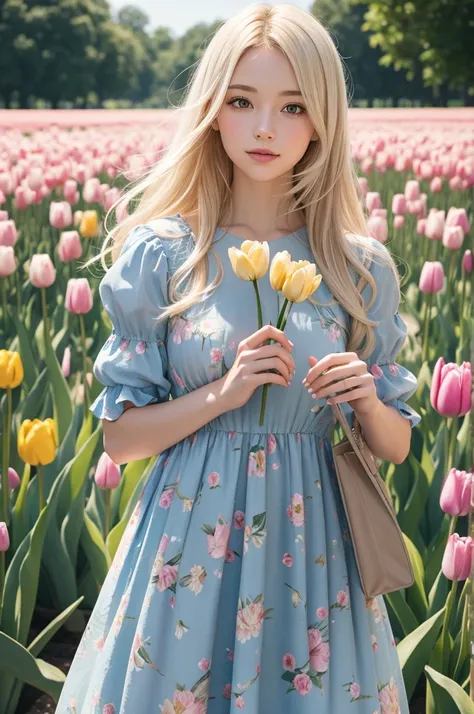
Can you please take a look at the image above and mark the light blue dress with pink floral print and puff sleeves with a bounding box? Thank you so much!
[56,214,420,714]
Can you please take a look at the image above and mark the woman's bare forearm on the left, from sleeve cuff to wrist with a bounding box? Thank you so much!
[102,378,229,464]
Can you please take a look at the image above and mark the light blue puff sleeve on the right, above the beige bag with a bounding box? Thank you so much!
[362,242,421,428]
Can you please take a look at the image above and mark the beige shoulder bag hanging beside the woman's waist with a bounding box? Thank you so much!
[332,404,414,598]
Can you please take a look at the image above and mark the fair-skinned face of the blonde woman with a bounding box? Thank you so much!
[213,49,317,181]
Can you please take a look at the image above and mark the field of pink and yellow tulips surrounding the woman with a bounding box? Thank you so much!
[0,110,474,714]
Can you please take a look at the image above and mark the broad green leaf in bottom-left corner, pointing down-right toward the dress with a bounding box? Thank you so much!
[0,631,66,700]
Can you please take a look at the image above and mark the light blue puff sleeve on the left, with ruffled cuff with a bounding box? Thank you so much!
[90,226,171,421]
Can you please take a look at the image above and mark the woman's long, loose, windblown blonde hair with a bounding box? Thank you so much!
[86,3,399,359]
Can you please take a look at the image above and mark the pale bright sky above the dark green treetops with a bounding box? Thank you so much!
[109,0,311,36]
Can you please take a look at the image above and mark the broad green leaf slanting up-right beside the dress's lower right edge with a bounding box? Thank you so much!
[397,608,445,699]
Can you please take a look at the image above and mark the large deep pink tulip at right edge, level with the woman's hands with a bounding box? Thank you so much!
[430,357,472,417]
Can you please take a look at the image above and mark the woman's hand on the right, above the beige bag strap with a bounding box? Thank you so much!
[303,352,380,414]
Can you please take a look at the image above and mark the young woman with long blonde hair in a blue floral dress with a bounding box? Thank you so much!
[56,4,420,714]
